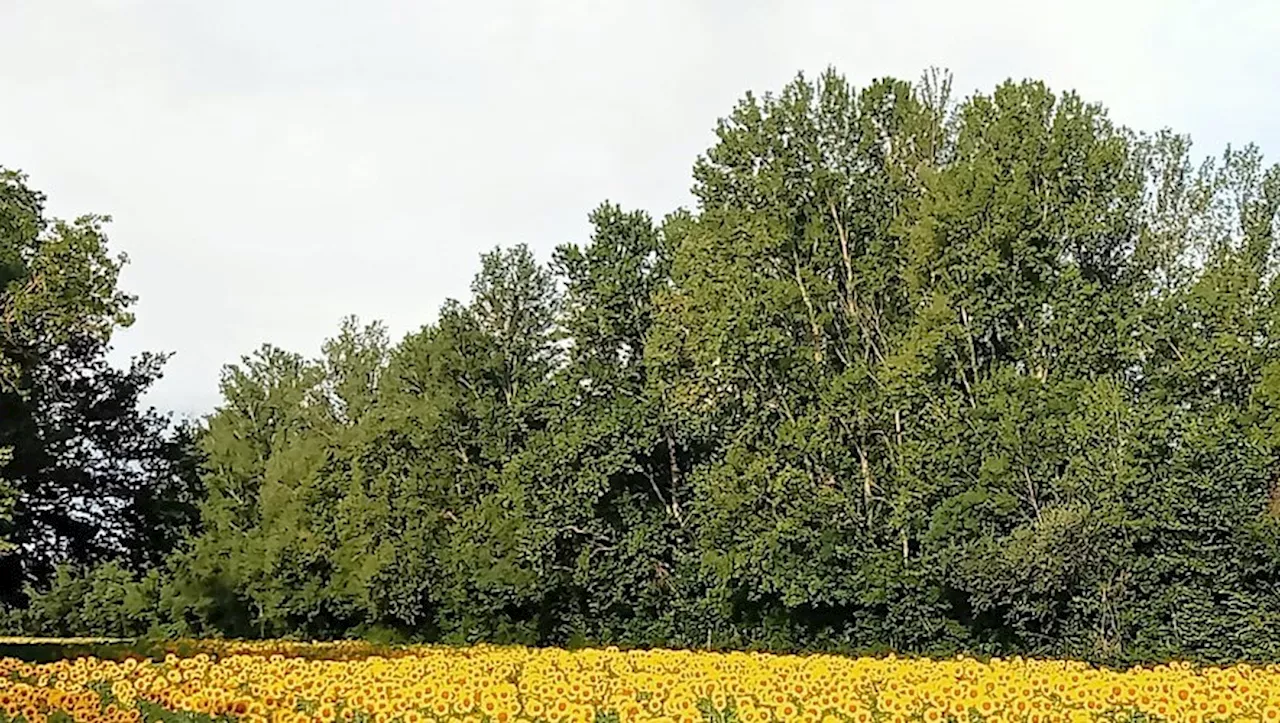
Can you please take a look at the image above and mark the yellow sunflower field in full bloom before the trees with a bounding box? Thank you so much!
[0,642,1280,723]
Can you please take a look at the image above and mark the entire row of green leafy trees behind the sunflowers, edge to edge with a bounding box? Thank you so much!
[0,70,1280,662]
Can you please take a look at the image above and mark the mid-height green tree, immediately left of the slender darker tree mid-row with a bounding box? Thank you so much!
[374,246,559,641]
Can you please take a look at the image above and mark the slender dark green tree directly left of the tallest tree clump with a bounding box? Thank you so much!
[507,203,689,642]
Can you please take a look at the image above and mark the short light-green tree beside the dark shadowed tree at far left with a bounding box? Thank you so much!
[169,346,358,636]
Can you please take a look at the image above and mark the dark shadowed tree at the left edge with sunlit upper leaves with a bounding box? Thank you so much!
[0,166,192,601]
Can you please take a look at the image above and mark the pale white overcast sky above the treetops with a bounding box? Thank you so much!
[0,0,1280,415]
